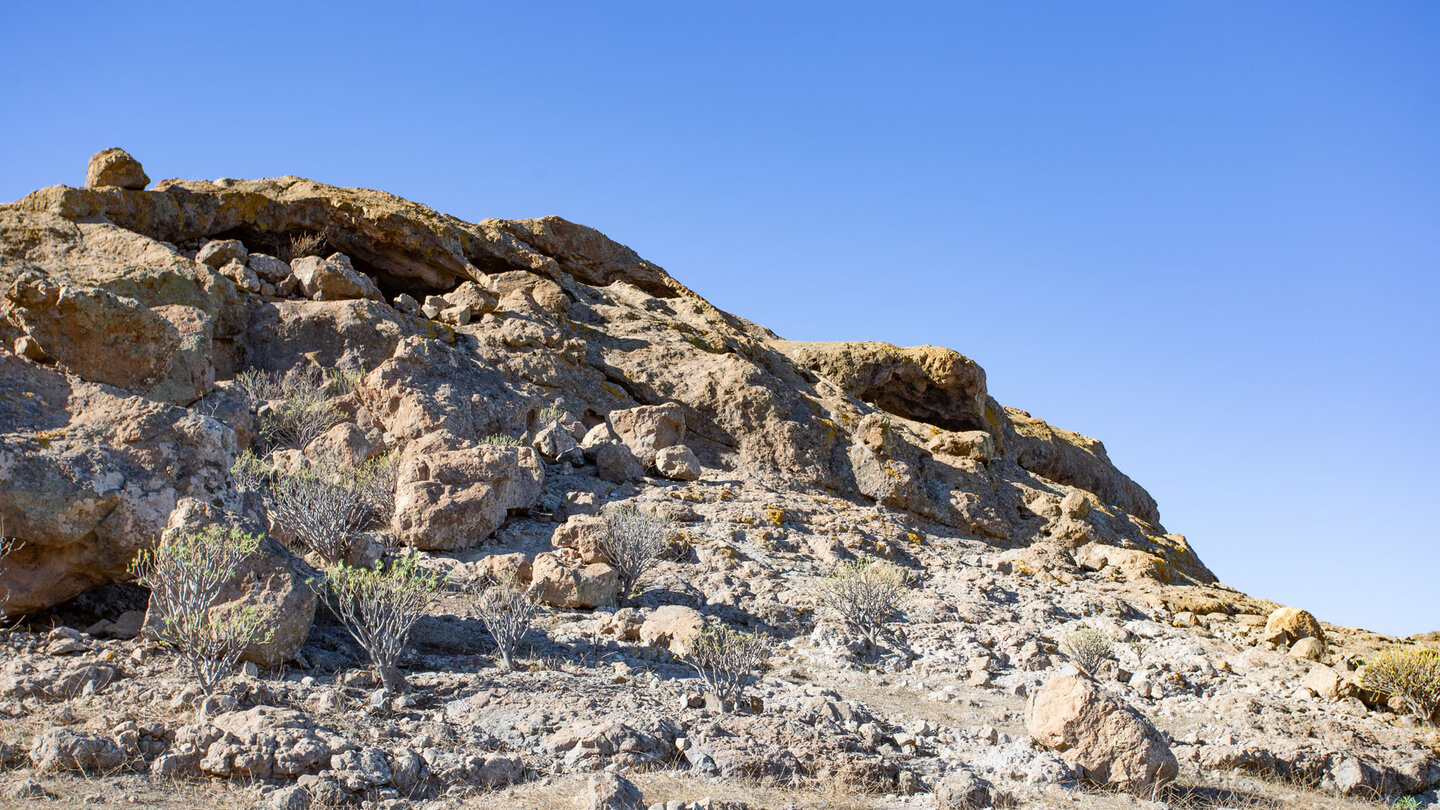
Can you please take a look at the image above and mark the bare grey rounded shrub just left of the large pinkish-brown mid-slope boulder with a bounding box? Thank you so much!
[266,467,374,564]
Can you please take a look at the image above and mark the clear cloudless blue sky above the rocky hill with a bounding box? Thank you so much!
[0,0,1440,634]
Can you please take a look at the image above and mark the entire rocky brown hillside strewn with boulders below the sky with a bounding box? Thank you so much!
[0,150,1440,809]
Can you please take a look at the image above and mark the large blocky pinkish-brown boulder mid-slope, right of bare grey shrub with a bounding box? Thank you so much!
[393,434,544,551]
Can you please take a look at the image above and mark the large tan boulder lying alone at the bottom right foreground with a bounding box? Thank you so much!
[1025,672,1179,793]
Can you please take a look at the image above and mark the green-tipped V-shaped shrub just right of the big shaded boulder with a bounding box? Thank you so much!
[318,556,445,689]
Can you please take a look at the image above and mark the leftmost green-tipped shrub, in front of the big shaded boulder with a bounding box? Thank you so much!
[131,526,274,695]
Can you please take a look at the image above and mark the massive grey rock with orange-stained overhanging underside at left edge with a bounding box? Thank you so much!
[0,352,235,613]
